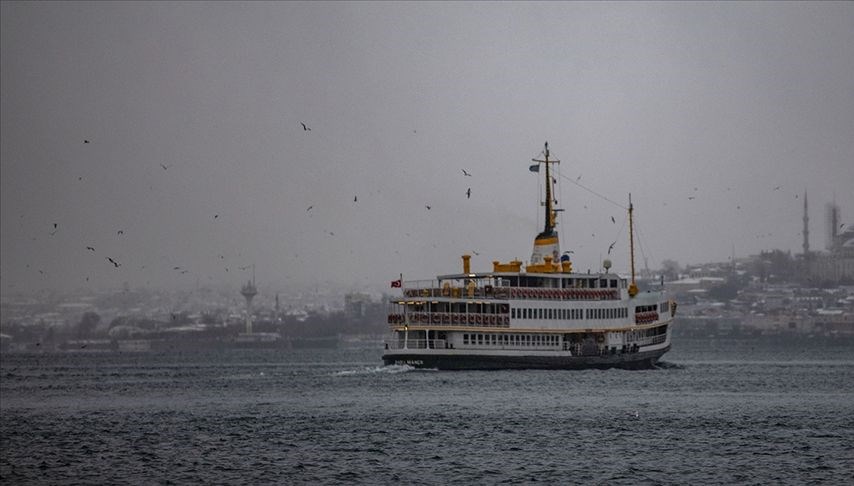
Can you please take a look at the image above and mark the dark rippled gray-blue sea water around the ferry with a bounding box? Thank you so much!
[0,338,854,484]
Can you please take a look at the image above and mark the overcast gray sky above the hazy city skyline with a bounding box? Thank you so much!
[0,2,854,293]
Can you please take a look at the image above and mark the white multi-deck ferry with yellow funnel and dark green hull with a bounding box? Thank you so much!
[382,142,676,370]
